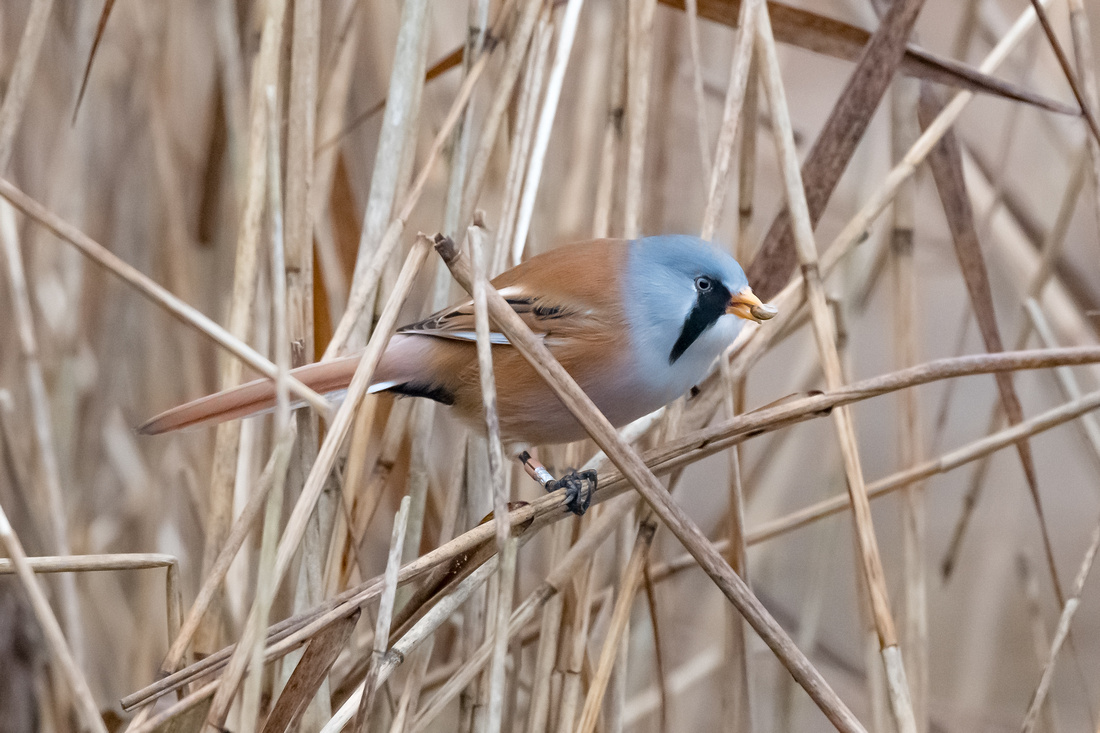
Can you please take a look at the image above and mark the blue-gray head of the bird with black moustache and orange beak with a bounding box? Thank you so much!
[624,234,774,396]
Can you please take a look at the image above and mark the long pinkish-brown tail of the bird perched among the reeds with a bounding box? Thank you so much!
[138,354,365,435]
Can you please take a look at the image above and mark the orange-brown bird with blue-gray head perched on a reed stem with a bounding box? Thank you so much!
[139,234,777,513]
